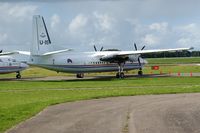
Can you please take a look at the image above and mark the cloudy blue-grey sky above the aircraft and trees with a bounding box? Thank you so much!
[0,0,200,51]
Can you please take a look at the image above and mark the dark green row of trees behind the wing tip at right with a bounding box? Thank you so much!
[142,51,200,58]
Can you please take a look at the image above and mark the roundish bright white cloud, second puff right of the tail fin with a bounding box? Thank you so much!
[69,14,88,34]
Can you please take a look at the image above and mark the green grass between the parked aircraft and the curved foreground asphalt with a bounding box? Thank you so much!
[0,77,200,132]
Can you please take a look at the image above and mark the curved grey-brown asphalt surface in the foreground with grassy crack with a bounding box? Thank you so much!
[8,93,200,133]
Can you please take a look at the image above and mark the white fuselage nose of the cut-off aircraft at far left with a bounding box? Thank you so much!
[0,56,28,74]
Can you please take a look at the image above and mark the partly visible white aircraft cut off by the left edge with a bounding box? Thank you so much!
[0,50,28,79]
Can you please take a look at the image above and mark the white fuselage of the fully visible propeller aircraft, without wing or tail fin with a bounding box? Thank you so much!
[29,51,147,73]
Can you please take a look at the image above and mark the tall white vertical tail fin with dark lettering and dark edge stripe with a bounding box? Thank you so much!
[31,15,51,55]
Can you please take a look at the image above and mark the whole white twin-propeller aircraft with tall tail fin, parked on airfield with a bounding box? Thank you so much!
[29,15,190,78]
